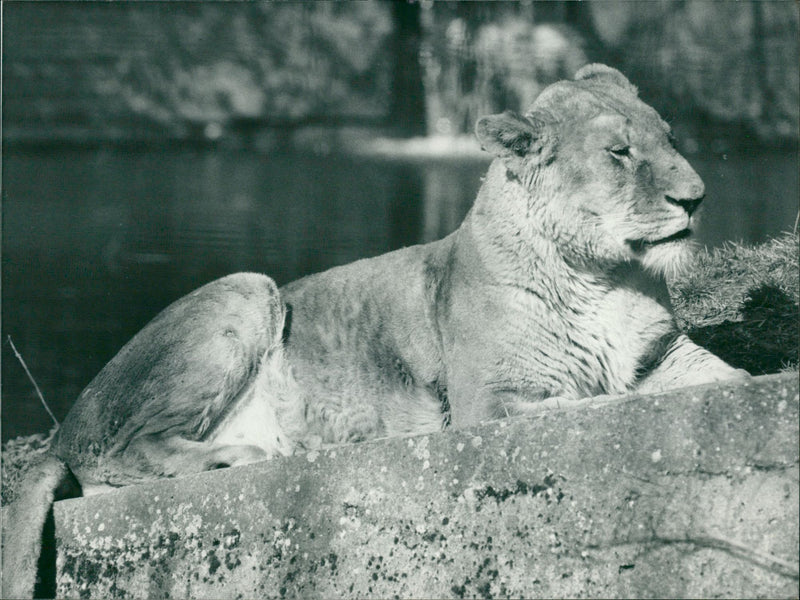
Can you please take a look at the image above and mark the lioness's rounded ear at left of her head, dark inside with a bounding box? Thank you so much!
[475,110,544,159]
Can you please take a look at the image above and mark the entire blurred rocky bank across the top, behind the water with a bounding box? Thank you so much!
[3,0,800,148]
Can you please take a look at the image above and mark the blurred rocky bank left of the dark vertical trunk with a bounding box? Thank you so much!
[4,2,392,139]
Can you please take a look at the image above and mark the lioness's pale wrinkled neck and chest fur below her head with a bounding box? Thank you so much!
[456,159,674,397]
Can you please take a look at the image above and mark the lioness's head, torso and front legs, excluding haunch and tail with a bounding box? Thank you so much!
[281,65,742,436]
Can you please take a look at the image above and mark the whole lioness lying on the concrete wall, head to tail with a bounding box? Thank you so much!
[3,65,742,595]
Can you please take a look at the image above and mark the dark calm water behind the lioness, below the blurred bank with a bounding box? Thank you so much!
[2,144,798,440]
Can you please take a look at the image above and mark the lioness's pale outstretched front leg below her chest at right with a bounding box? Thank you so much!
[634,334,750,394]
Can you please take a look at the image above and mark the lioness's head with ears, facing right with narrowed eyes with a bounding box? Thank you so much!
[476,64,705,273]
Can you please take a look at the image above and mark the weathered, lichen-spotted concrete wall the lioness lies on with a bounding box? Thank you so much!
[55,374,798,598]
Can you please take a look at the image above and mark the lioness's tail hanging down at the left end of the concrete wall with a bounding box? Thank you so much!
[2,453,75,598]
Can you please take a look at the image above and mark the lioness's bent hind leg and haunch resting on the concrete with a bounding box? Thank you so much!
[56,273,304,493]
